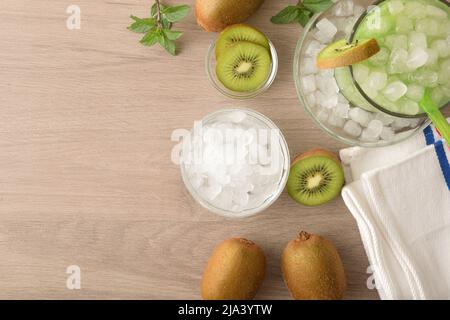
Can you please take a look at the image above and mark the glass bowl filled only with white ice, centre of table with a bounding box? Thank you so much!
[180,108,290,218]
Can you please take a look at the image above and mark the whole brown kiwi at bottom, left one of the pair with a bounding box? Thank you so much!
[201,238,266,300]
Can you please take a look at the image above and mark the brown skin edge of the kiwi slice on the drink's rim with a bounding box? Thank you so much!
[317,39,380,69]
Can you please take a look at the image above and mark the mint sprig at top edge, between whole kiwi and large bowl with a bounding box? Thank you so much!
[270,0,333,27]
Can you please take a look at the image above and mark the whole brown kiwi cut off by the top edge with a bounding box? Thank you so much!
[195,0,264,32]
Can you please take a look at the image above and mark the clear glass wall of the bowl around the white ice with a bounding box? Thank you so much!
[180,108,291,218]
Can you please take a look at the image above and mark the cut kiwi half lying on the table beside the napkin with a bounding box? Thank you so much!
[287,149,344,206]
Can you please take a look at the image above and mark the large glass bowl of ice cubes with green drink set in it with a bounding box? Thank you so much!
[294,0,450,147]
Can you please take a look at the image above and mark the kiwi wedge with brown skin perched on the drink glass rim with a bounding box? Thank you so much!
[317,39,380,69]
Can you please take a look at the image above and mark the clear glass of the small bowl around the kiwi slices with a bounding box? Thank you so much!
[205,40,278,100]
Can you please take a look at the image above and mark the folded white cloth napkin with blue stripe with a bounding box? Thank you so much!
[340,127,450,299]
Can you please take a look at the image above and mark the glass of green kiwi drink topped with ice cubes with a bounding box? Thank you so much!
[335,0,450,116]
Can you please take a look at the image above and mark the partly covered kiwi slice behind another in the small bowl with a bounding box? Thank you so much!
[216,23,270,59]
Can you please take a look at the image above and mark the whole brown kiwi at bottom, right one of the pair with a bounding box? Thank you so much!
[281,231,347,300]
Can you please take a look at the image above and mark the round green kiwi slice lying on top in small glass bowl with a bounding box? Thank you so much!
[216,41,272,92]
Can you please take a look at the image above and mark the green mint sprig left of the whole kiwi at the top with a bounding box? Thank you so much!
[128,0,190,55]
